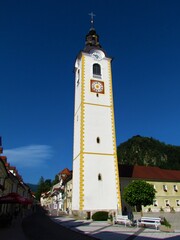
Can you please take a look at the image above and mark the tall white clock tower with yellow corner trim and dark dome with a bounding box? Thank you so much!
[72,23,121,216]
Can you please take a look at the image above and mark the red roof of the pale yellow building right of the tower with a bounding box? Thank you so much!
[119,164,180,181]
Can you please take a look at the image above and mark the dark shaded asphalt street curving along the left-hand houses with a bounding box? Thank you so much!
[0,206,95,240]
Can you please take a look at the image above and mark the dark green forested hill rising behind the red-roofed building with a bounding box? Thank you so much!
[117,135,180,170]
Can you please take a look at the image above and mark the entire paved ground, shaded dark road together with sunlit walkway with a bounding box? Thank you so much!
[0,211,180,240]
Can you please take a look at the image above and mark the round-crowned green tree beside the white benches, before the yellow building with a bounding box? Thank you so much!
[123,180,156,215]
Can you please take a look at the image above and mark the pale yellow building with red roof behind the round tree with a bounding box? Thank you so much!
[119,165,180,212]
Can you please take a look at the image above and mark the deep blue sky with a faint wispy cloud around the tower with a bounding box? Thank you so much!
[0,0,180,183]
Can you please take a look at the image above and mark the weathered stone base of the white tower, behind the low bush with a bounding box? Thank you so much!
[72,209,122,219]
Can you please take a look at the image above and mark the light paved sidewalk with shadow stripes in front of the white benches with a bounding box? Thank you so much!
[51,217,180,240]
